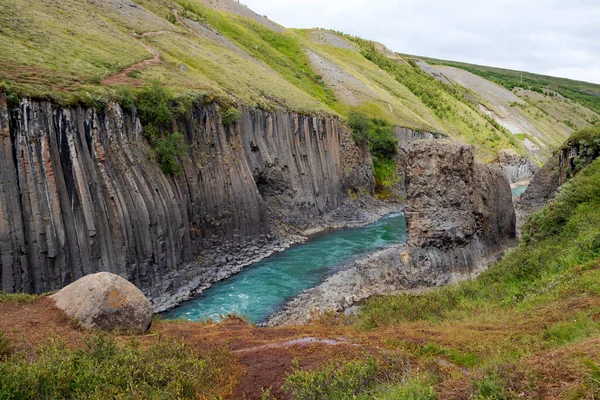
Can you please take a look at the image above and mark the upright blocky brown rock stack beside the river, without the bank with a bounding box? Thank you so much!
[406,141,515,274]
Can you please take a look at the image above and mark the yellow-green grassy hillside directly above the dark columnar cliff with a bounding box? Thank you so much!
[0,0,596,159]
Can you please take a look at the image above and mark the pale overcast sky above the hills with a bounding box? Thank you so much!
[241,0,600,83]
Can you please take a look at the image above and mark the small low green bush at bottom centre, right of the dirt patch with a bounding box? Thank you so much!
[282,356,378,400]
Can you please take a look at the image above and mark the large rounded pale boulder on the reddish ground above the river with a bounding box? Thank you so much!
[51,272,153,333]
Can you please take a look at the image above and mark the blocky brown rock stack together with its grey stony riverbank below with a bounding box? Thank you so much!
[268,140,515,325]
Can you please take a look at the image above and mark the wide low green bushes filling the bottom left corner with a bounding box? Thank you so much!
[0,335,233,399]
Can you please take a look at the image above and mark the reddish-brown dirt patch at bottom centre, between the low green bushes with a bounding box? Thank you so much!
[147,318,365,399]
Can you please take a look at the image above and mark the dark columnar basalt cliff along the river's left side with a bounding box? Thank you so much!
[0,94,372,296]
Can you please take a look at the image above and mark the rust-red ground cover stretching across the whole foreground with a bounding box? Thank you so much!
[0,297,600,399]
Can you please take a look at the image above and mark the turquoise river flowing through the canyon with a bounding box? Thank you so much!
[164,187,525,322]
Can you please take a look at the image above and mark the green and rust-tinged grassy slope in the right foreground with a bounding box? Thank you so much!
[346,137,600,398]
